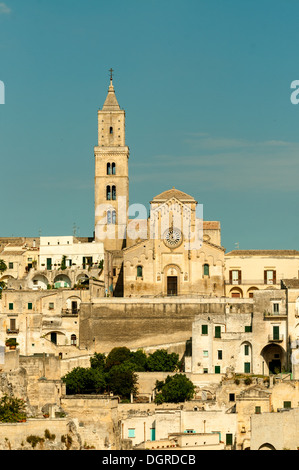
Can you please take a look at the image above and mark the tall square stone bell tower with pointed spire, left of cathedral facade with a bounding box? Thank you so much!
[94,69,129,251]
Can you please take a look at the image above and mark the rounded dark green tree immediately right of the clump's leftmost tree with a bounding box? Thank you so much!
[106,364,137,398]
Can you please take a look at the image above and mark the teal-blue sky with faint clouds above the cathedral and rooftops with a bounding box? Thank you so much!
[0,0,299,251]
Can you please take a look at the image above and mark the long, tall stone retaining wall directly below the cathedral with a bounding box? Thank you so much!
[79,298,252,354]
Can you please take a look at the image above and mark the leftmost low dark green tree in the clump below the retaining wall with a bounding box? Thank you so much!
[62,367,106,395]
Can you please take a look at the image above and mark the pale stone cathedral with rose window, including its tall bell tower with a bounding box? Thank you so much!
[94,76,225,297]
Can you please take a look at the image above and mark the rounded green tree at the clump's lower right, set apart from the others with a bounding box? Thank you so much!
[155,374,195,404]
